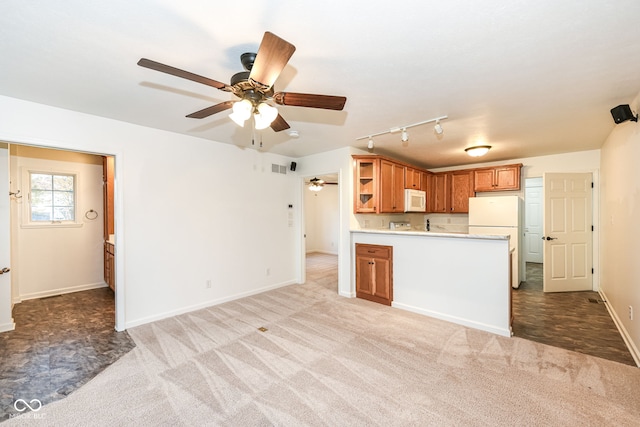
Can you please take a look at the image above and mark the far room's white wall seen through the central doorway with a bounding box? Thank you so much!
[303,185,340,255]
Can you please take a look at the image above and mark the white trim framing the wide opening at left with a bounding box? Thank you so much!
[0,134,126,332]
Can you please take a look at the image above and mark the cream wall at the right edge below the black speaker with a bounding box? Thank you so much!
[600,94,640,364]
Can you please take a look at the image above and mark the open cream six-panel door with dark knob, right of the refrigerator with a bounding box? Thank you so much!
[542,173,593,292]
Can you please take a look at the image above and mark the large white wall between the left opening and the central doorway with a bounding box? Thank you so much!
[0,97,301,329]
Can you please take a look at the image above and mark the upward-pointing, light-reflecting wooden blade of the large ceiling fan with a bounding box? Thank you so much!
[249,31,296,90]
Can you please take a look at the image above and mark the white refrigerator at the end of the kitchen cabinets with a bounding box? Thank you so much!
[469,196,525,288]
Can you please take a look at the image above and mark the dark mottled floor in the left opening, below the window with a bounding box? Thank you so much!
[0,287,135,421]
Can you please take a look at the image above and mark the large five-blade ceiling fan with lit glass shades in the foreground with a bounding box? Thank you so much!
[138,31,347,132]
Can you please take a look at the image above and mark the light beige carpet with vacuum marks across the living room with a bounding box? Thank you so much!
[3,256,640,426]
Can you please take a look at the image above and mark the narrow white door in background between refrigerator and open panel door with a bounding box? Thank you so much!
[524,178,543,263]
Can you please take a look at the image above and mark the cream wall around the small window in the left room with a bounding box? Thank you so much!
[10,145,106,303]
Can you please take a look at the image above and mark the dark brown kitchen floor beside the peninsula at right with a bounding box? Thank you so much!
[512,263,636,366]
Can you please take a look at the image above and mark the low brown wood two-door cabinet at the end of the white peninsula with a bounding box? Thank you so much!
[356,243,393,305]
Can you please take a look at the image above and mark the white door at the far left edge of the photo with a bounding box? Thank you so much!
[0,143,15,332]
